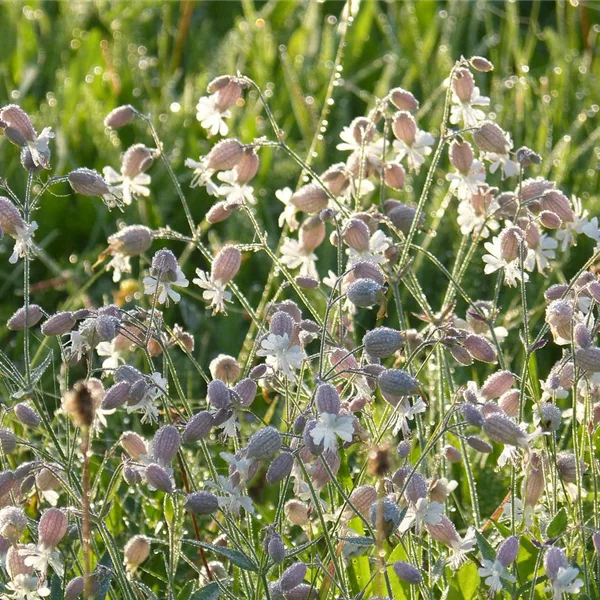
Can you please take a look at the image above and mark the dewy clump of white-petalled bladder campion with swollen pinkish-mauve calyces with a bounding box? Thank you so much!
[0,5,600,600]
